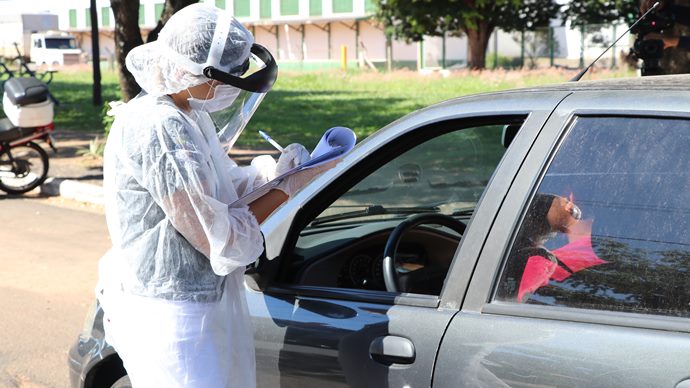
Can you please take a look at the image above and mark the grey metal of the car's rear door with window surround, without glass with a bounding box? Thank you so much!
[434,90,690,387]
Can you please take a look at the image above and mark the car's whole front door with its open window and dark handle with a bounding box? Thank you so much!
[247,93,564,387]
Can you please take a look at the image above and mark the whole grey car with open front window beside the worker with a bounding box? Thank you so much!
[69,76,690,388]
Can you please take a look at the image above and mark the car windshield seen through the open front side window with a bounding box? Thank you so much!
[312,125,505,226]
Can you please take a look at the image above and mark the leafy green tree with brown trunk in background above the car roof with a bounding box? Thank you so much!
[370,0,559,69]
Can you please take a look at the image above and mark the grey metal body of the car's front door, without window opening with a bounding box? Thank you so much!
[248,93,566,387]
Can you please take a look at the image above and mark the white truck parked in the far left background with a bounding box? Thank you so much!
[0,13,82,65]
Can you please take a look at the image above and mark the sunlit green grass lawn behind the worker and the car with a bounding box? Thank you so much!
[22,66,632,149]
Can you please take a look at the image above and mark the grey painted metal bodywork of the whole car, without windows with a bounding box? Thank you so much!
[70,76,690,388]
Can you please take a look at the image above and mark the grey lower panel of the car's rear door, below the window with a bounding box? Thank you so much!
[433,313,690,388]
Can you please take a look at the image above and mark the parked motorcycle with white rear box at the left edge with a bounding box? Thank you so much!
[0,77,57,194]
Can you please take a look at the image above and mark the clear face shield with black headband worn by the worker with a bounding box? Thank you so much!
[204,44,278,150]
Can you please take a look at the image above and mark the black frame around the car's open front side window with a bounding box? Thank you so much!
[255,112,530,307]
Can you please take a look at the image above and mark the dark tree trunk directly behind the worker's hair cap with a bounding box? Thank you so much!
[110,0,144,101]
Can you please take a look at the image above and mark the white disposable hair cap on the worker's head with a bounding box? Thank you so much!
[126,3,254,96]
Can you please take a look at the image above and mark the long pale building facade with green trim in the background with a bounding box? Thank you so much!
[0,0,627,70]
